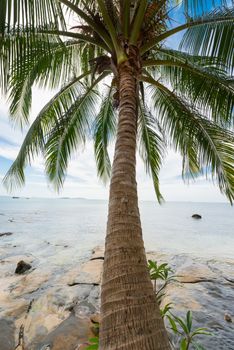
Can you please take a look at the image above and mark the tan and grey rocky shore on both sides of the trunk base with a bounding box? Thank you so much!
[0,243,234,350]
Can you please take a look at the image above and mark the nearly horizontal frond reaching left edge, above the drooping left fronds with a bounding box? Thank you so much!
[0,28,108,92]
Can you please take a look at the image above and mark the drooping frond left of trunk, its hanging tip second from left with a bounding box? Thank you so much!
[44,73,107,190]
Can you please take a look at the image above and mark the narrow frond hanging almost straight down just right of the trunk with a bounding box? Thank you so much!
[138,103,166,203]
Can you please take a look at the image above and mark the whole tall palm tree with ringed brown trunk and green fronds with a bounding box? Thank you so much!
[0,0,234,350]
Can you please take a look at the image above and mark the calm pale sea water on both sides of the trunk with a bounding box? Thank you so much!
[0,197,234,267]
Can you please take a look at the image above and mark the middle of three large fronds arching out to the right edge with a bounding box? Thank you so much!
[143,53,234,127]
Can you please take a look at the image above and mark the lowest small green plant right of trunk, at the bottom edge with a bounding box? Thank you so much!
[166,311,212,350]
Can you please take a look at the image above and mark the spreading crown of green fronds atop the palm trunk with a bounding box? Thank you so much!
[0,0,234,202]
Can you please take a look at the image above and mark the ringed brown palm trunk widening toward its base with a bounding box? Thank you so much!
[100,54,170,350]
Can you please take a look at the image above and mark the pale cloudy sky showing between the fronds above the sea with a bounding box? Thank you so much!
[0,0,230,202]
